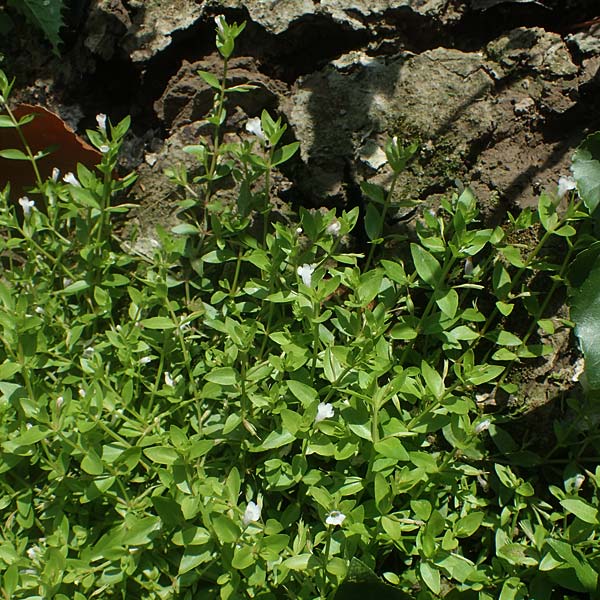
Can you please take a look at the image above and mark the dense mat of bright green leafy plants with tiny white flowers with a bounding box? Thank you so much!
[0,12,600,600]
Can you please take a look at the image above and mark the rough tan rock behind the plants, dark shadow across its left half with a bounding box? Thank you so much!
[284,48,493,199]
